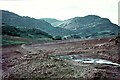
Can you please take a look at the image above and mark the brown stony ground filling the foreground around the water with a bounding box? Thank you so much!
[3,37,120,80]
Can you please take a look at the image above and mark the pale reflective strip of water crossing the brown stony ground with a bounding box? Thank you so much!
[54,55,120,67]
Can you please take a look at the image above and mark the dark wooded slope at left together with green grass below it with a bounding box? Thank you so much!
[0,23,53,46]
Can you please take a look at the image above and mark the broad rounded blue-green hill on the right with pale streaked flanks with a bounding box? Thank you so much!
[45,15,120,38]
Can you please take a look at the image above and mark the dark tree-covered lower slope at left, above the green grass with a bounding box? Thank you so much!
[2,23,52,38]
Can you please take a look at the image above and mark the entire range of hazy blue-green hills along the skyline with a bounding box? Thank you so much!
[2,10,120,38]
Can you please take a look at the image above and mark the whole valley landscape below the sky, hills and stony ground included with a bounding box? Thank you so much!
[0,10,120,80]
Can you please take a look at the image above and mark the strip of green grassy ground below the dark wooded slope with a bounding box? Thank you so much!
[0,35,51,46]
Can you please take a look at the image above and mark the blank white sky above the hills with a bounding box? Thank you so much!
[0,0,119,24]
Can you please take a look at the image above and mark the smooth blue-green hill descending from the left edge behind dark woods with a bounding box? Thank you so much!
[2,10,74,36]
